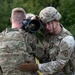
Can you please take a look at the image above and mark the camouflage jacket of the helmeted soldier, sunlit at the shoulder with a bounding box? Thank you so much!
[39,27,75,75]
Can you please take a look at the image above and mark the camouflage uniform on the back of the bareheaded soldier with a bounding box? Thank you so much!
[0,28,37,75]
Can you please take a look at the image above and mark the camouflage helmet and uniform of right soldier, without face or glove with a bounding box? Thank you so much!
[39,7,75,75]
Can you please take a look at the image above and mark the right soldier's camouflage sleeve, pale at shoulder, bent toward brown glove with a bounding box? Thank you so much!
[38,36,74,74]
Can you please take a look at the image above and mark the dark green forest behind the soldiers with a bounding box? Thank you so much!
[0,0,75,36]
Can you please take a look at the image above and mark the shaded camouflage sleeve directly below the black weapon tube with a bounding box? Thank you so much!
[25,33,43,60]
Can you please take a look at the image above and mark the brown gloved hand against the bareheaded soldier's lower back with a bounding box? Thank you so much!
[19,63,38,72]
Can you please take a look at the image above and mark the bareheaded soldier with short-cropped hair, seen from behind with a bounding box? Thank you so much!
[0,7,42,75]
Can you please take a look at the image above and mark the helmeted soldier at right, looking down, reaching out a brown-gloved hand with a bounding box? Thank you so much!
[19,7,74,75]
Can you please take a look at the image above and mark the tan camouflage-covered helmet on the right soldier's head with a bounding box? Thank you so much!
[39,7,61,23]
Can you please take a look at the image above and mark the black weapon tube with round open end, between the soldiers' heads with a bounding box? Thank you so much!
[22,19,42,33]
